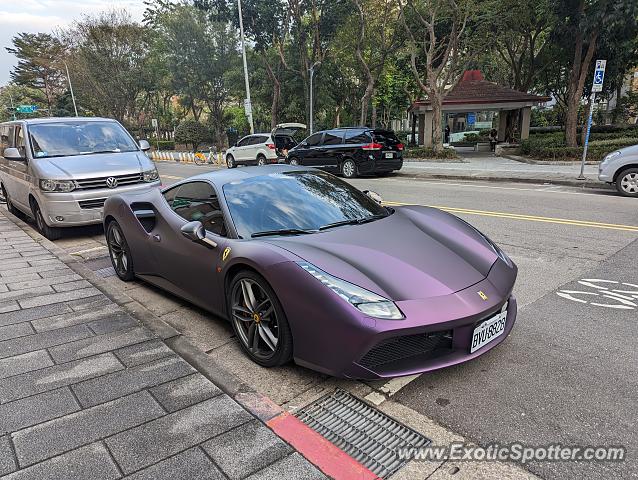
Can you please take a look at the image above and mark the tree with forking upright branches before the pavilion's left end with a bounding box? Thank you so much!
[399,0,475,152]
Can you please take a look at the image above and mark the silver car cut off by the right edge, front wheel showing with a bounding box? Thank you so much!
[598,145,638,197]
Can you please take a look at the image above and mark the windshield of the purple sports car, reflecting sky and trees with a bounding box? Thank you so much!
[223,171,388,238]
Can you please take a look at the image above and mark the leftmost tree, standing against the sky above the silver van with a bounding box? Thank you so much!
[6,33,66,115]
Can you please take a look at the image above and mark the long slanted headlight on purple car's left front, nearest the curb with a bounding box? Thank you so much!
[297,262,404,320]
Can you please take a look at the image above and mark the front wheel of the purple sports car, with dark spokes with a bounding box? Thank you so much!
[226,270,292,367]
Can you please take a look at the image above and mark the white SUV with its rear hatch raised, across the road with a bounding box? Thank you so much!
[226,123,306,168]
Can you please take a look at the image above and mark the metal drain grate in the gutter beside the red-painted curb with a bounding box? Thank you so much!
[296,389,430,478]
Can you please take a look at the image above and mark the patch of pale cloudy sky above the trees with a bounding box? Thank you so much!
[0,0,145,85]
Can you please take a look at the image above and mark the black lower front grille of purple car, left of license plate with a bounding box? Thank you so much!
[358,330,452,370]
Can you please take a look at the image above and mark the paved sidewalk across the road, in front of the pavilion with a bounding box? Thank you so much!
[399,152,611,188]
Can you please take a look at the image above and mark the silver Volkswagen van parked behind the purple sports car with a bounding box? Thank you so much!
[0,118,160,239]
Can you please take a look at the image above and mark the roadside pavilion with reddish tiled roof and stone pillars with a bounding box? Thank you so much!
[409,70,550,146]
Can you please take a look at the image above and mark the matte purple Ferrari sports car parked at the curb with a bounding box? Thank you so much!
[104,165,517,379]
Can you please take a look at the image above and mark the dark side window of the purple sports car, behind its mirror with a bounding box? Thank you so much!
[171,182,227,237]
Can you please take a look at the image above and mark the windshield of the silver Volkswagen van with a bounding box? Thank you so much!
[29,120,138,158]
